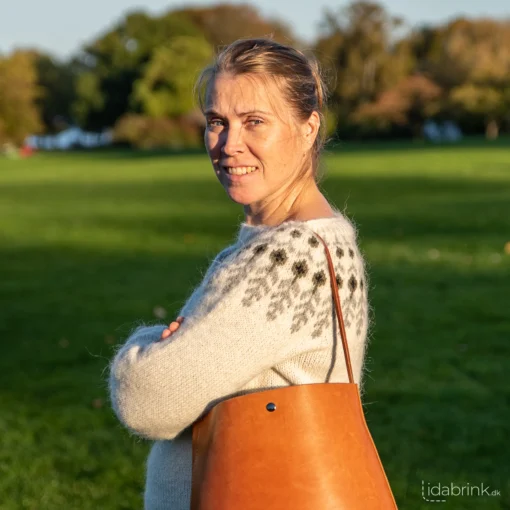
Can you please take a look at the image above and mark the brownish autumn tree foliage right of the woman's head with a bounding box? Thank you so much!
[315,1,510,136]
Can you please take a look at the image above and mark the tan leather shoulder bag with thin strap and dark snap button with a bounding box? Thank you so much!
[191,234,397,510]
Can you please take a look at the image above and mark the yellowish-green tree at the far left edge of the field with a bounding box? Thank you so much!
[0,51,42,145]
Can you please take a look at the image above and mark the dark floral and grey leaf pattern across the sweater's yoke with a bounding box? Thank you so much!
[198,226,367,338]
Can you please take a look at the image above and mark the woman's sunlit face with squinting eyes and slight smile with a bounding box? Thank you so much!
[205,74,316,205]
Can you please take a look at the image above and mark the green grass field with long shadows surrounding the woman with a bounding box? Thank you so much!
[0,142,510,510]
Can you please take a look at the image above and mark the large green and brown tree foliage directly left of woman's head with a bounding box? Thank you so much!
[70,4,293,129]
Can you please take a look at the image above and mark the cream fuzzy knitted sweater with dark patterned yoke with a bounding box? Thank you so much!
[110,211,368,510]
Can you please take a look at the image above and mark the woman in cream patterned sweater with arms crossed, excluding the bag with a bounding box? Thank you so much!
[110,39,368,510]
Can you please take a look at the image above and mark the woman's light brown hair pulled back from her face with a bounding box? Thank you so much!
[195,38,327,181]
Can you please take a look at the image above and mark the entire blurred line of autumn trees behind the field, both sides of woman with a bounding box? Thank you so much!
[0,1,510,148]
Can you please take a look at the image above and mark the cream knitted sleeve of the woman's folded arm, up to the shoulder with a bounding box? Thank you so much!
[110,227,354,439]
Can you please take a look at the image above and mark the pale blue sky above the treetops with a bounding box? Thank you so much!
[0,0,510,59]
